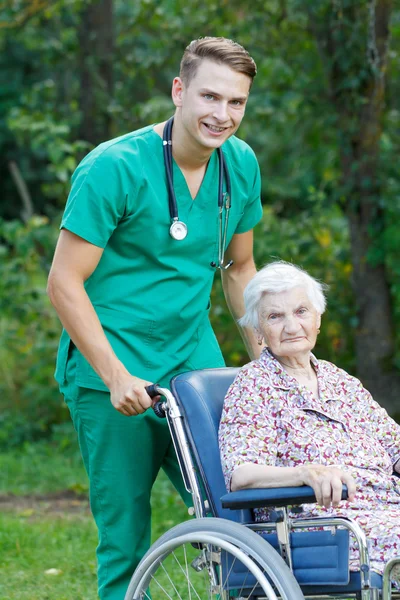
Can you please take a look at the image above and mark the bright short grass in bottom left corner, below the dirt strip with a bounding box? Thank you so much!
[0,511,97,600]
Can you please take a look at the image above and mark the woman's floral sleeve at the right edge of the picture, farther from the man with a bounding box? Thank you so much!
[360,384,400,465]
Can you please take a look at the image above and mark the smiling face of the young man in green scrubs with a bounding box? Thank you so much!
[172,60,251,149]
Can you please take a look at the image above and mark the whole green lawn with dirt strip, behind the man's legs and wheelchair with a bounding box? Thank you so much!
[0,436,188,600]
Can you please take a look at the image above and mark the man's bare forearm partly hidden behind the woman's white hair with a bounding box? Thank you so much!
[221,262,261,360]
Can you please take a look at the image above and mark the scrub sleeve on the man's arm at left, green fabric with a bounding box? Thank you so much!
[60,148,126,248]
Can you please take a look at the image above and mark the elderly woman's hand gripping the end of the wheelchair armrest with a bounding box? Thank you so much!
[298,464,356,508]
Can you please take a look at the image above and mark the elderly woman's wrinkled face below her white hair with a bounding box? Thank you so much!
[258,287,321,358]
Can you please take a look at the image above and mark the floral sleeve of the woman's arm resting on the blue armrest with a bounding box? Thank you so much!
[219,367,278,490]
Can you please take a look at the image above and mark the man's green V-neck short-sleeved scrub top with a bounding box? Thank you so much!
[56,126,262,390]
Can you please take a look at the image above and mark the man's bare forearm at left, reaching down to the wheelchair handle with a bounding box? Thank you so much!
[48,276,127,387]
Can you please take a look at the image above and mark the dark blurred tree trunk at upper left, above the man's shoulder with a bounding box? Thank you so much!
[79,0,114,145]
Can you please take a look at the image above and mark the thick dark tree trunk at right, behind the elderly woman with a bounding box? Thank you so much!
[309,0,400,413]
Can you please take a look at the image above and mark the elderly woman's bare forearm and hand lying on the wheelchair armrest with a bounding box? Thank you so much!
[231,463,356,508]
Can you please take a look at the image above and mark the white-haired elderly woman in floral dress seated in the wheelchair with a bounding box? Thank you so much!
[219,262,400,578]
